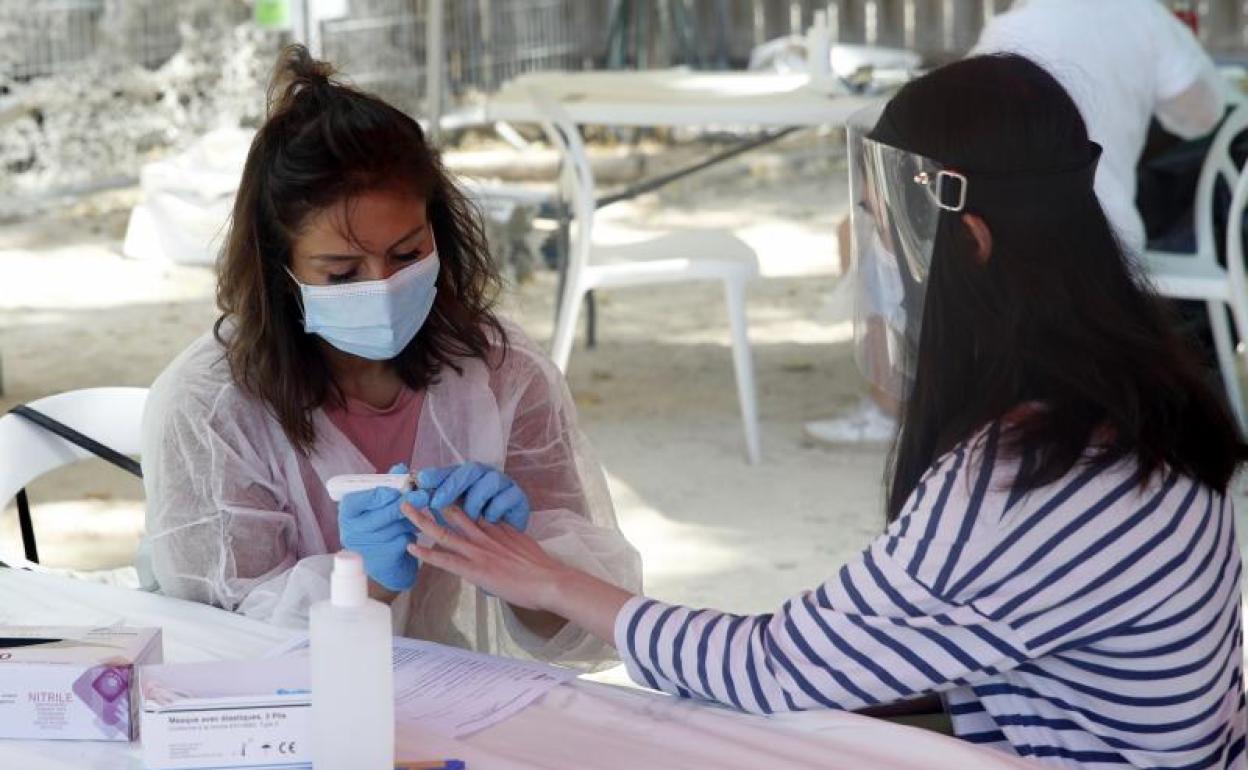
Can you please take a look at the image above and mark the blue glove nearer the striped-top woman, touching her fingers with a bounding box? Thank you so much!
[412,463,529,532]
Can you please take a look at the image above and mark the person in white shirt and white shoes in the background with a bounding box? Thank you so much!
[805,0,1226,444]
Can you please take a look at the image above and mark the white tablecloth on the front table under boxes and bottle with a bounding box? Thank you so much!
[0,569,1038,770]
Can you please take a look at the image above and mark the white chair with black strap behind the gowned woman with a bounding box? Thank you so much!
[0,388,147,568]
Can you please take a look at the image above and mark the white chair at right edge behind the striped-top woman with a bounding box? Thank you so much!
[1143,105,1248,428]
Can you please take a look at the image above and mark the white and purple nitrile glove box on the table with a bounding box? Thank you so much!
[0,625,161,741]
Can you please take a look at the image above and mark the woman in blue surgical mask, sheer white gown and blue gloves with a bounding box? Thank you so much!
[144,47,640,666]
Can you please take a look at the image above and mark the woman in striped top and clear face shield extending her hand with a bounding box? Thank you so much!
[406,56,1248,769]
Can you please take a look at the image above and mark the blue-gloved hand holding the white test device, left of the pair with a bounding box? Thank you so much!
[338,465,427,592]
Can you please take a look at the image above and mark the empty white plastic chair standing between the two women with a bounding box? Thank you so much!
[530,90,761,464]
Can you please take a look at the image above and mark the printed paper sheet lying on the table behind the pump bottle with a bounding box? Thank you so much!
[275,638,577,738]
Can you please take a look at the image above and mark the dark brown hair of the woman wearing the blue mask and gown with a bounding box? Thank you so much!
[215,45,507,452]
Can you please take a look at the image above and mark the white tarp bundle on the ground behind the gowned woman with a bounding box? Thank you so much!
[122,129,253,265]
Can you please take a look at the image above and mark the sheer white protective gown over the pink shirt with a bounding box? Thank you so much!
[142,318,641,669]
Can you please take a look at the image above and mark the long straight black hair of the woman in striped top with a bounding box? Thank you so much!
[874,55,1248,520]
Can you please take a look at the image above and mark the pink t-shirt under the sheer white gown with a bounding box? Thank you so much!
[324,388,424,473]
